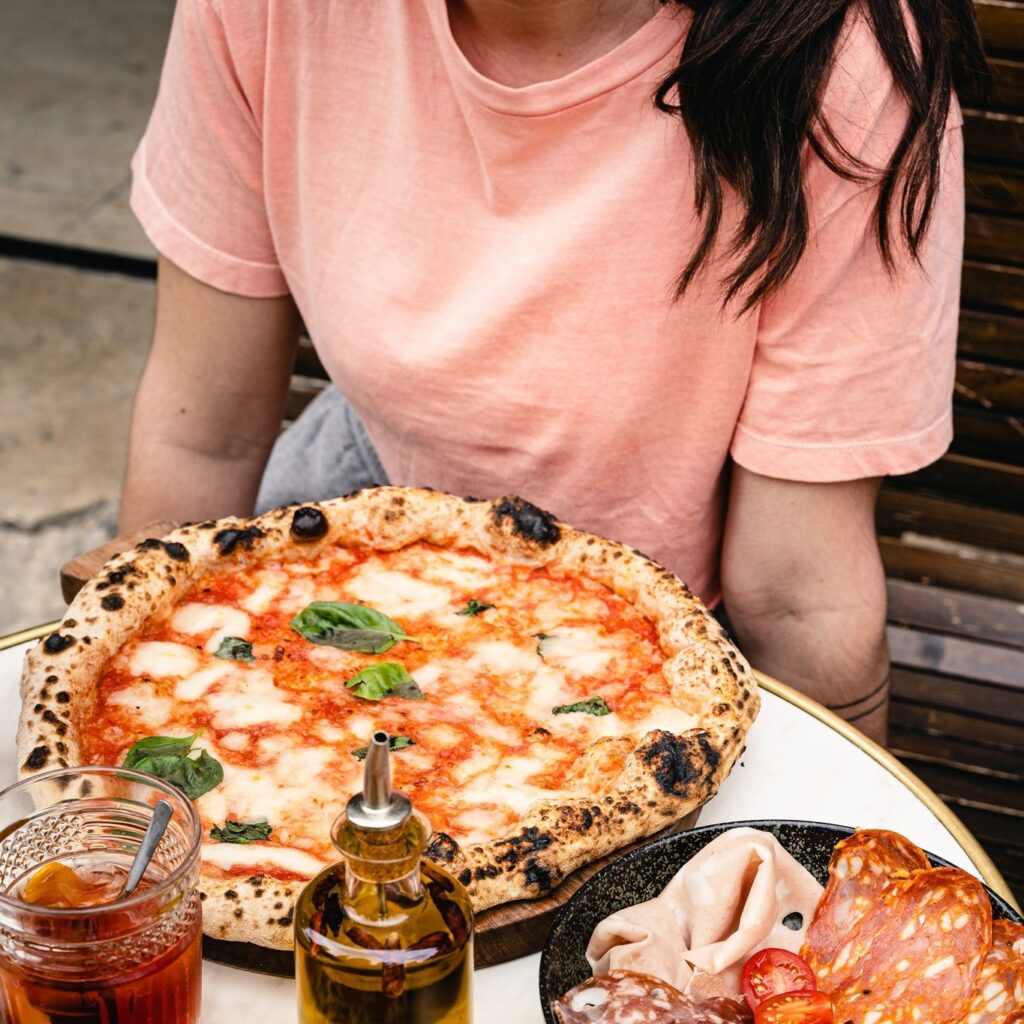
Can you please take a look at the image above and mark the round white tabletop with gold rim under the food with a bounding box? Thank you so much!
[0,626,1012,1024]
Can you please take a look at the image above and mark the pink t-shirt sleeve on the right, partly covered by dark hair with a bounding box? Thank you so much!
[731,12,964,482]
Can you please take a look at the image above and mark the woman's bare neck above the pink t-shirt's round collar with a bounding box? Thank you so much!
[446,0,659,87]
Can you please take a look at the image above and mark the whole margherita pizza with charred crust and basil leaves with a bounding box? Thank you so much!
[18,487,759,948]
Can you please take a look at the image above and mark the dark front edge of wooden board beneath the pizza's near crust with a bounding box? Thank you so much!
[203,808,700,978]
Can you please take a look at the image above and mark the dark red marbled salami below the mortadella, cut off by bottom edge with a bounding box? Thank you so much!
[555,971,754,1024]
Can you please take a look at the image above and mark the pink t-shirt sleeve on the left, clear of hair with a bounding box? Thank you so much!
[131,0,288,296]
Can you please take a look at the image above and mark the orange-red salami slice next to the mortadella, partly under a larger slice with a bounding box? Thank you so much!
[801,828,929,968]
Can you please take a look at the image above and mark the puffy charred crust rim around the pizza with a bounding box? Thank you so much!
[17,487,759,948]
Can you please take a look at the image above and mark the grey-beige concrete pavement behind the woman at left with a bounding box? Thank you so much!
[0,0,174,634]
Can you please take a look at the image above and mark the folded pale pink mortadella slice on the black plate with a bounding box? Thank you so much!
[587,827,822,996]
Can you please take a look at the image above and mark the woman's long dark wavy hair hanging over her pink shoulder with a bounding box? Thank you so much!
[655,0,988,312]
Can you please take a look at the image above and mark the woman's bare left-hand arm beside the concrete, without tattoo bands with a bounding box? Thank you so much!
[120,257,299,531]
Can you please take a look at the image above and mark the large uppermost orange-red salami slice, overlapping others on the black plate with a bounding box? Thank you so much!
[807,867,992,1024]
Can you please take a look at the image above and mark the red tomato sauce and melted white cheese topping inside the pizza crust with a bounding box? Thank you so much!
[82,542,696,881]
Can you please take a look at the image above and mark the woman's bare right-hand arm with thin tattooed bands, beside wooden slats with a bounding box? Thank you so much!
[722,466,889,742]
